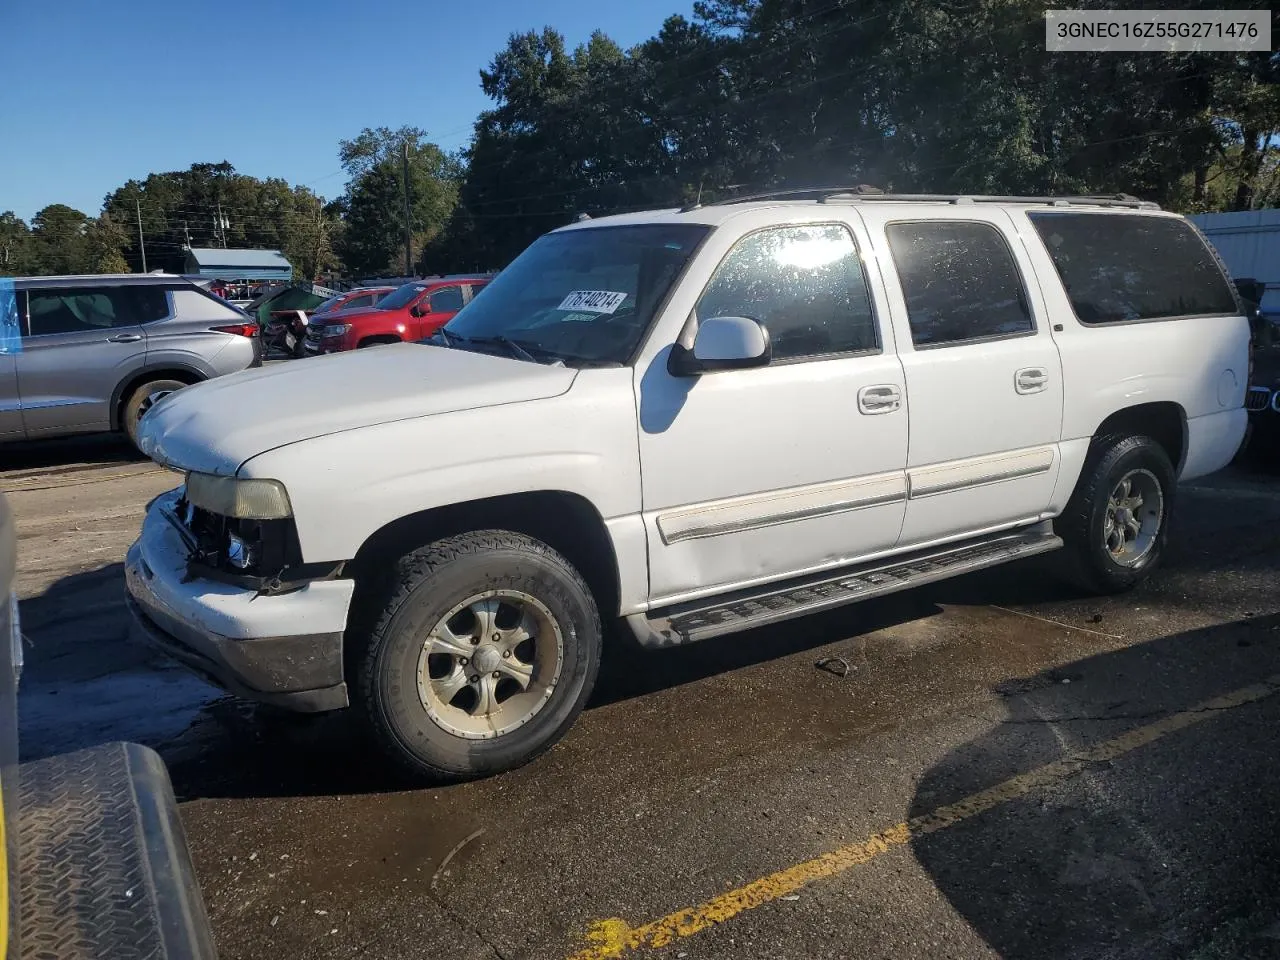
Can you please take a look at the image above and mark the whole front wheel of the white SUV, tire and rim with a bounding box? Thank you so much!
[353,530,602,782]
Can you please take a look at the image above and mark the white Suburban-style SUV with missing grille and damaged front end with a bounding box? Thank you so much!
[127,191,1249,778]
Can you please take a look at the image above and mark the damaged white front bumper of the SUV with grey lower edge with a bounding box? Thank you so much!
[124,492,355,713]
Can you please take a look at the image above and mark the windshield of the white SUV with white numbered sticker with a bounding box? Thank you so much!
[445,224,710,364]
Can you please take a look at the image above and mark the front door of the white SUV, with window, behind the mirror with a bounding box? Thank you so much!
[636,220,908,605]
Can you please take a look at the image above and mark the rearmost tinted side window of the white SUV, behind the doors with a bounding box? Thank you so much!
[1028,212,1238,324]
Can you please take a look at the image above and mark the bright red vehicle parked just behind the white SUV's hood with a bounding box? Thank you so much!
[306,274,492,356]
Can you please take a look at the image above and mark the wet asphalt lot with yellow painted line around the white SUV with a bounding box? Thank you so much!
[0,440,1280,960]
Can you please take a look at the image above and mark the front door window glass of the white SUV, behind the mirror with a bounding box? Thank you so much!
[695,224,879,360]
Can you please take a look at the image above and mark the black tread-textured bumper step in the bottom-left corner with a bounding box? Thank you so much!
[15,744,216,960]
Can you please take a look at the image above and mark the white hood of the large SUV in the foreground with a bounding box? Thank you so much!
[138,343,577,475]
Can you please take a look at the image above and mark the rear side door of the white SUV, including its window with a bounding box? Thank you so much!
[860,204,1062,548]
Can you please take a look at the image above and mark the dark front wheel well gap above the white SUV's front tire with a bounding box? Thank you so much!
[348,490,620,621]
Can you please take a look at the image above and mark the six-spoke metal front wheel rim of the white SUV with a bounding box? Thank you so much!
[417,590,564,740]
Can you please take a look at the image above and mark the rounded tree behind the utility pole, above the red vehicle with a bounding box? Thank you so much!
[337,127,462,275]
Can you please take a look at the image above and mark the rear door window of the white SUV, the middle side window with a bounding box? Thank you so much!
[884,220,1036,347]
